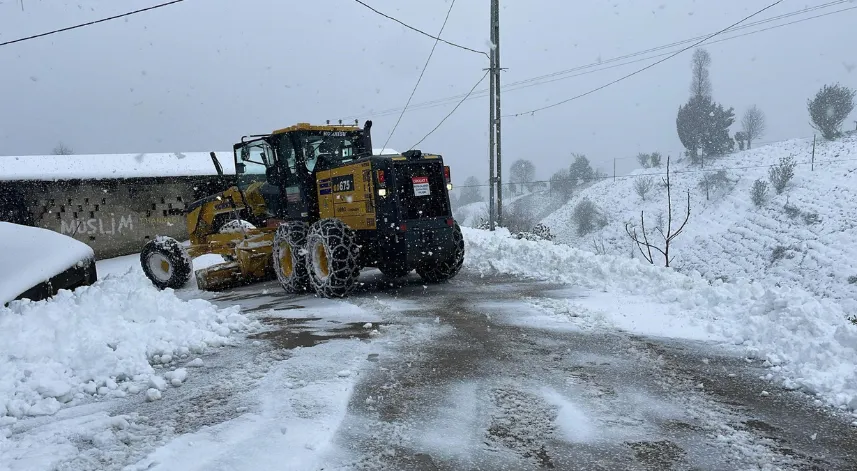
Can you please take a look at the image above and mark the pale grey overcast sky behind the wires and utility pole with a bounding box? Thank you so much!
[0,0,857,183]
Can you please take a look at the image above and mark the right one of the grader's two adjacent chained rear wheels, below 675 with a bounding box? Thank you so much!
[306,219,360,298]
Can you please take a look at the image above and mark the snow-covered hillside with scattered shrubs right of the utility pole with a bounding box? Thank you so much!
[544,136,857,316]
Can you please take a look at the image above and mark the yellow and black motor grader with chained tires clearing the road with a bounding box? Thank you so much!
[140,121,464,297]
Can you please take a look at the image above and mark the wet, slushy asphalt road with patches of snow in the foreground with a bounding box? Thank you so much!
[209,272,857,470]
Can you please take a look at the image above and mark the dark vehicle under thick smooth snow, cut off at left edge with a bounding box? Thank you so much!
[0,222,98,305]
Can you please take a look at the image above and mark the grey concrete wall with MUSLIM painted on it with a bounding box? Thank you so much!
[0,176,226,259]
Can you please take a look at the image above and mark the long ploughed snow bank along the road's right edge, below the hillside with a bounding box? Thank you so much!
[463,228,857,410]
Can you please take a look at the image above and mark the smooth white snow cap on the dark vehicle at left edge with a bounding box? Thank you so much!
[0,222,95,306]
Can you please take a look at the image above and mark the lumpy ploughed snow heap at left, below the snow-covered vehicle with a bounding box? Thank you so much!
[0,272,256,426]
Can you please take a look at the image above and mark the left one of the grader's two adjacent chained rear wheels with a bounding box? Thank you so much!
[273,222,310,293]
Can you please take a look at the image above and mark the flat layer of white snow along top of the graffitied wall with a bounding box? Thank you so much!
[0,151,235,181]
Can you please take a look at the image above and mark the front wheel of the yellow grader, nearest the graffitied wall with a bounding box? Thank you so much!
[140,236,193,289]
